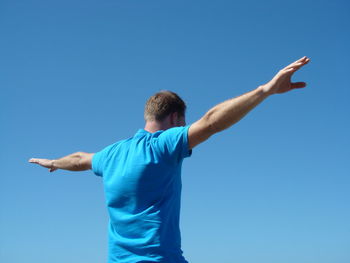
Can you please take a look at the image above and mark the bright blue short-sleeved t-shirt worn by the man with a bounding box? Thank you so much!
[92,126,191,263]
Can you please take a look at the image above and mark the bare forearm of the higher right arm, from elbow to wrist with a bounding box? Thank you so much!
[203,86,269,133]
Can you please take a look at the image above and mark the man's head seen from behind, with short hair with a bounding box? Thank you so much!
[144,90,186,132]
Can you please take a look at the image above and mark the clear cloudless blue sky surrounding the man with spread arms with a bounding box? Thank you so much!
[0,0,350,263]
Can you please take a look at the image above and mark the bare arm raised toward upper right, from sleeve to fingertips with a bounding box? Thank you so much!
[188,57,310,149]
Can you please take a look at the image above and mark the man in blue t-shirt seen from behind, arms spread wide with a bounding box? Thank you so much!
[29,57,309,263]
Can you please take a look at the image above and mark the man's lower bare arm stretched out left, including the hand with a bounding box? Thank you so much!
[29,152,94,172]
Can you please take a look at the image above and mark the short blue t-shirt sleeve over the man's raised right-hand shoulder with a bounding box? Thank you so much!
[156,126,192,161]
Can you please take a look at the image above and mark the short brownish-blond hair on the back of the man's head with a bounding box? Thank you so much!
[144,90,186,121]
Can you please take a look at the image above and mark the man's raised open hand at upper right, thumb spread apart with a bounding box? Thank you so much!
[261,57,310,95]
